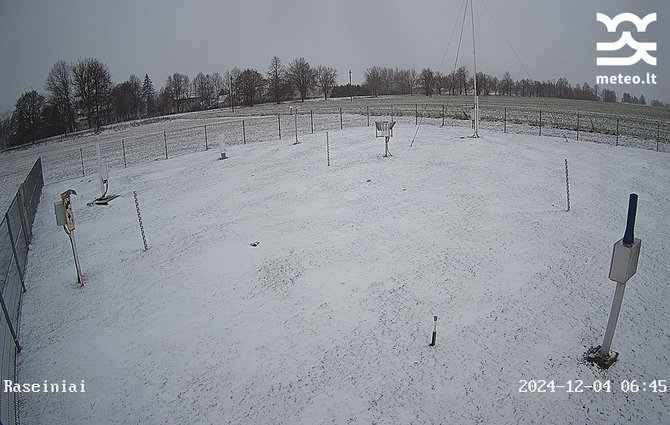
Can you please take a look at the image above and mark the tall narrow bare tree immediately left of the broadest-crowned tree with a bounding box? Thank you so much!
[44,59,75,134]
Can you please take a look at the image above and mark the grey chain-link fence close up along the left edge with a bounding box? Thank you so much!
[0,158,44,425]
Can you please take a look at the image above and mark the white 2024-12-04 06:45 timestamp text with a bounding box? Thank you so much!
[519,379,668,394]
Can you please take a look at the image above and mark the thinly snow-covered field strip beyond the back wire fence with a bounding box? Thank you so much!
[0,96,670,210]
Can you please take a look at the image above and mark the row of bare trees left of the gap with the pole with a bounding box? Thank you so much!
[0,56,337,148]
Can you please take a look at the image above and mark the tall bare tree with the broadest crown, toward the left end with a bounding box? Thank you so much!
[72,58,112,128]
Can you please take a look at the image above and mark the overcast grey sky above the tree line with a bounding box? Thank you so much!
[0,0,670,112]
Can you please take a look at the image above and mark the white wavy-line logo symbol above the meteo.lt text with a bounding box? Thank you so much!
[596,13,656,66]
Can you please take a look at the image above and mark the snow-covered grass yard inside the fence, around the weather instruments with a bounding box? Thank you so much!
[14,123,670,424]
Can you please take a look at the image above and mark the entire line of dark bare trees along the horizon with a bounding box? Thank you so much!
[0,56,670,148]
